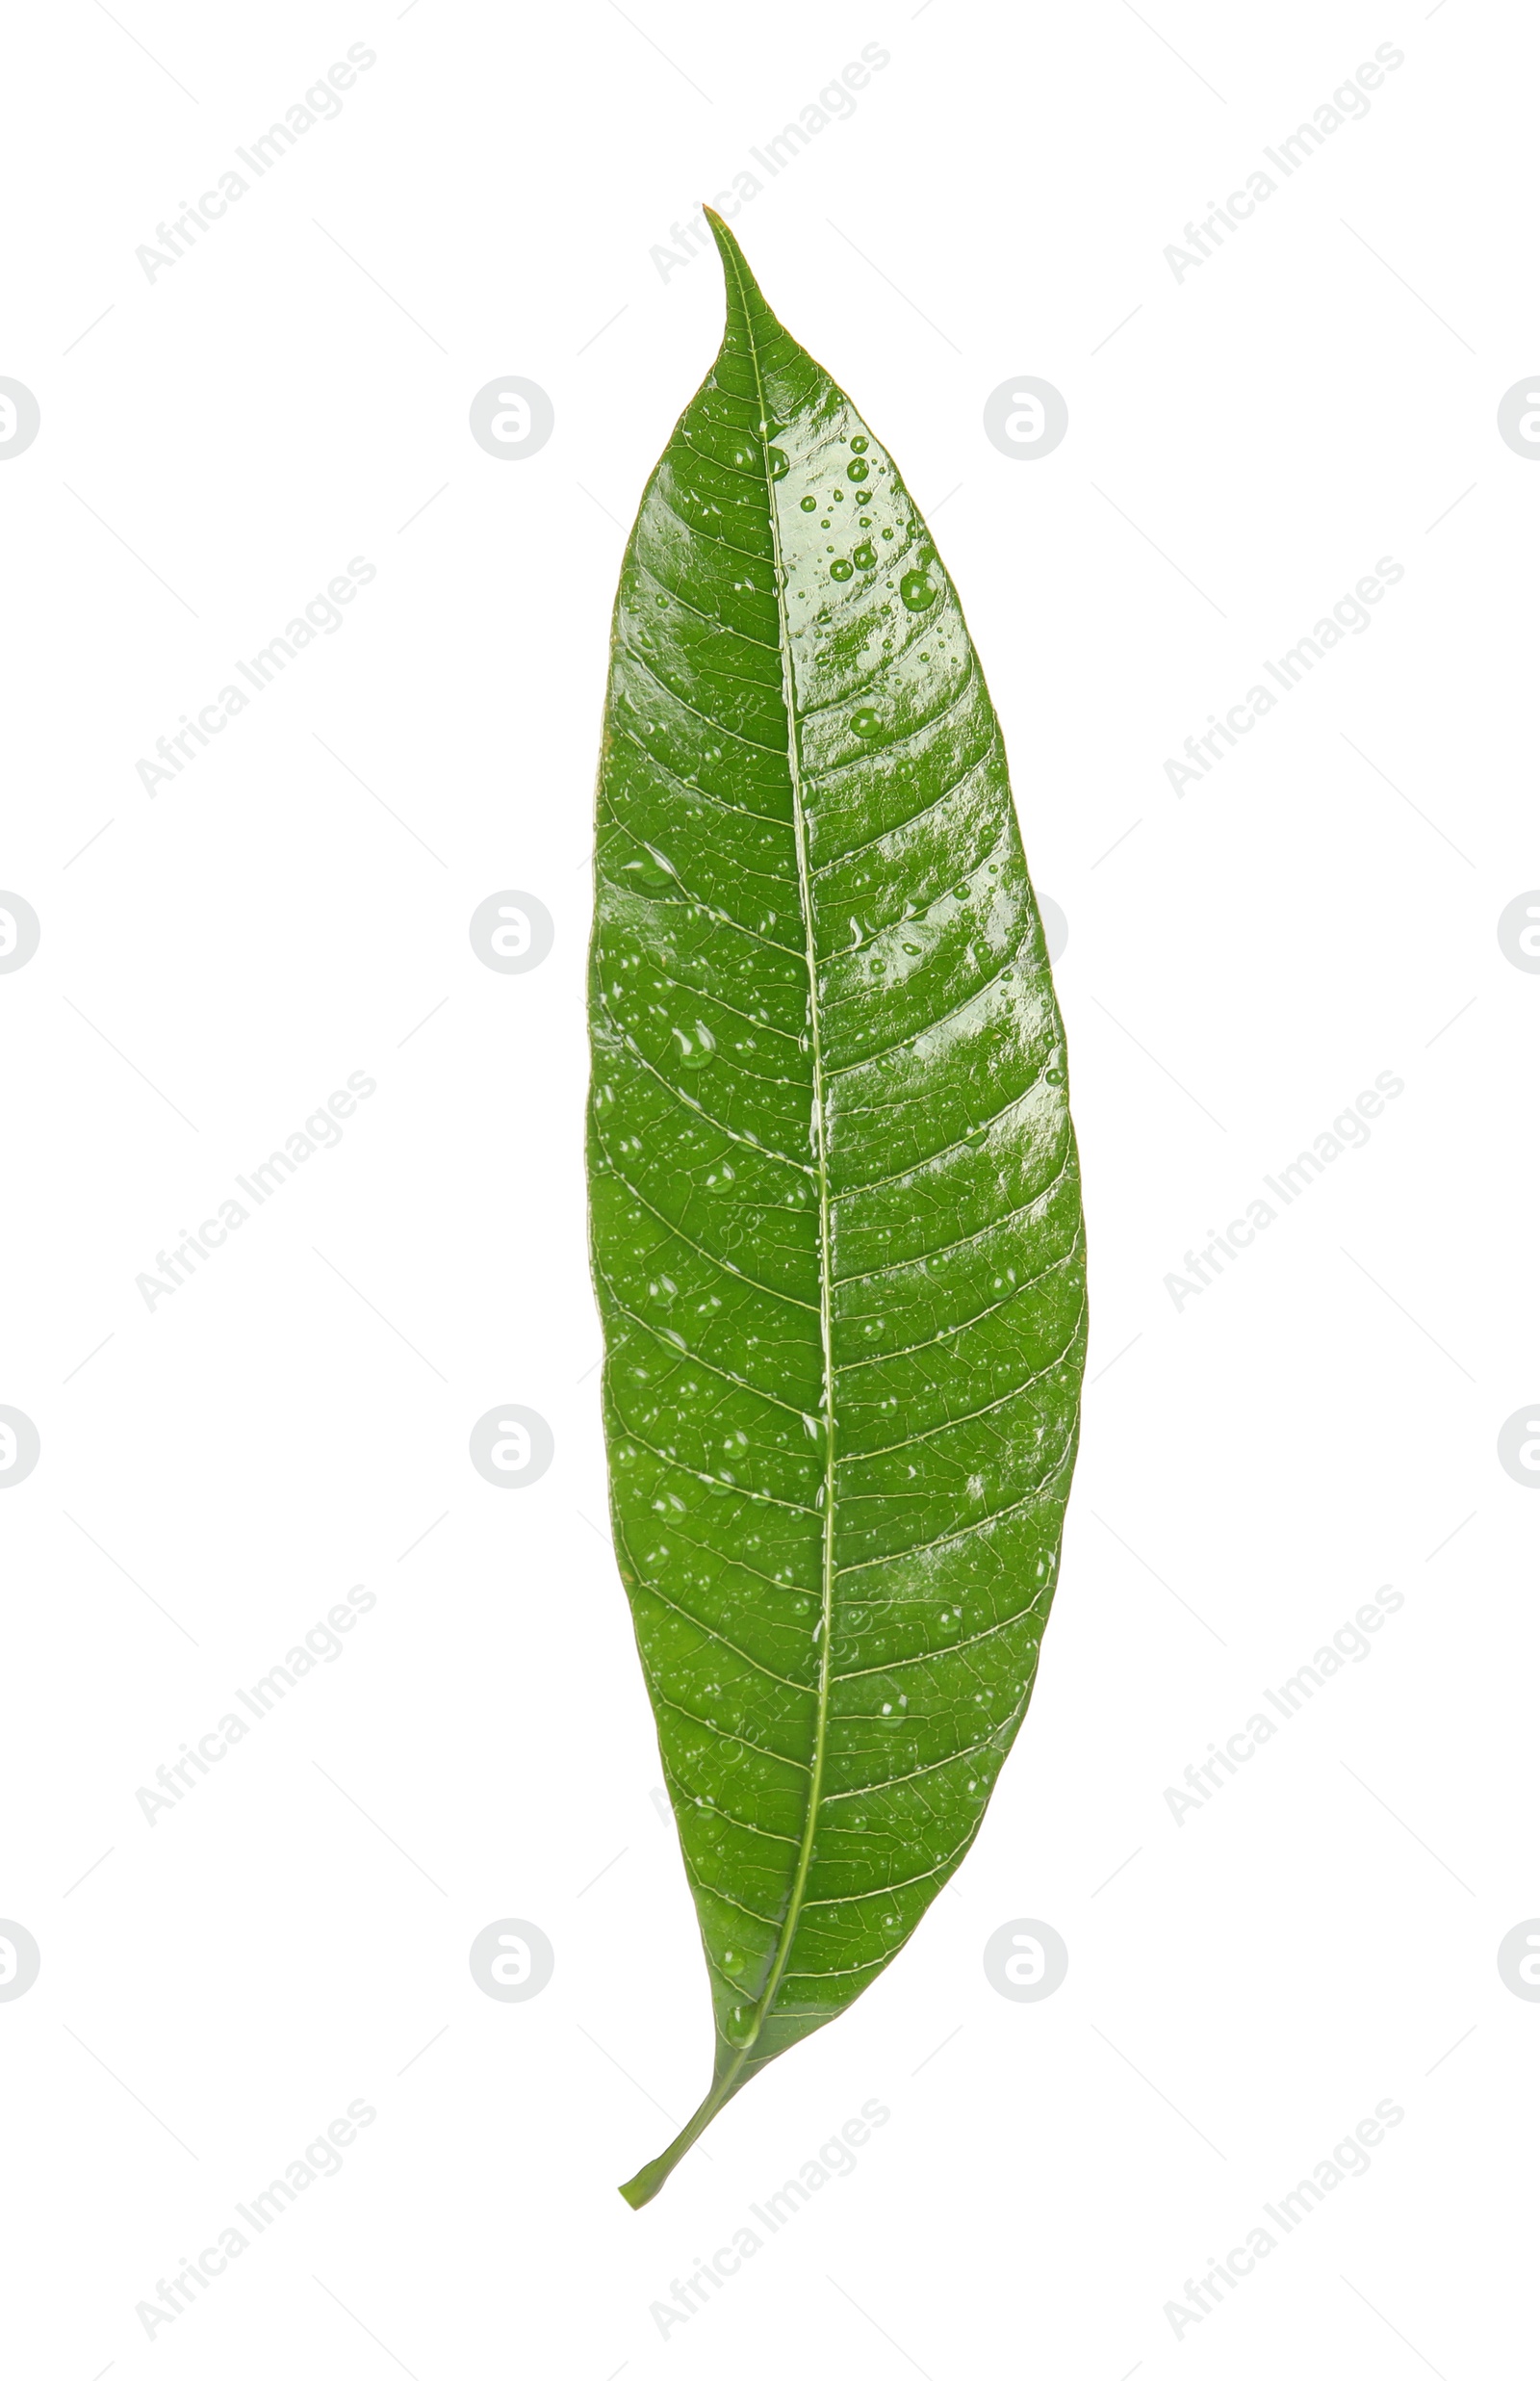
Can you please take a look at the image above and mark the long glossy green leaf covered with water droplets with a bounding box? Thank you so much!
[588,217,1086,2207]
